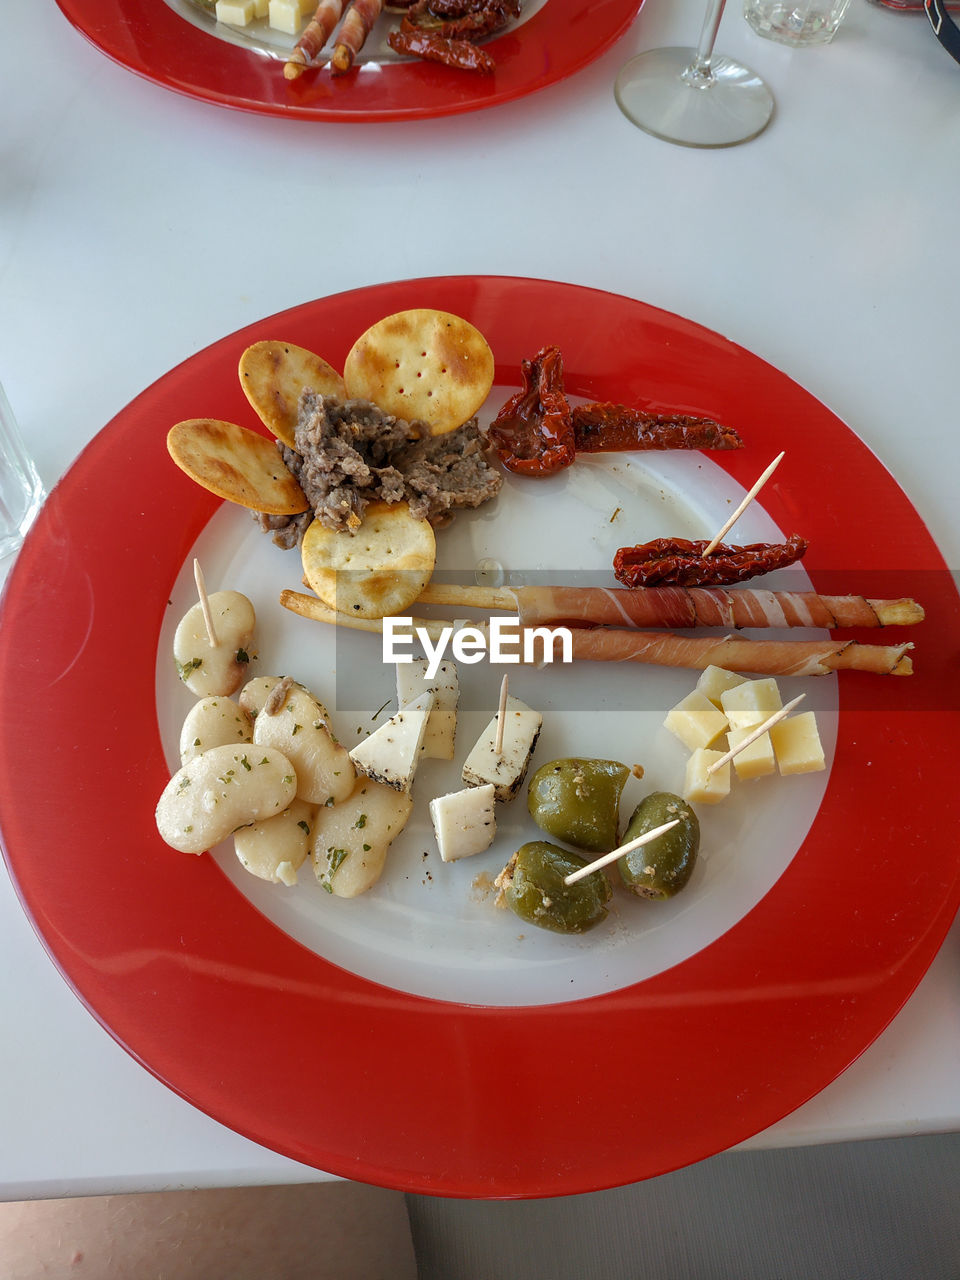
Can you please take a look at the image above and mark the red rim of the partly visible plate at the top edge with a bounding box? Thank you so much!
[50,0,643,123]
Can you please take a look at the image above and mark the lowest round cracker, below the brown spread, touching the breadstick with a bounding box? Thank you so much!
[301,502,436,618]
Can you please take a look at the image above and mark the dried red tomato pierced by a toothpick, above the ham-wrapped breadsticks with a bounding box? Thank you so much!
[613,534,808,586]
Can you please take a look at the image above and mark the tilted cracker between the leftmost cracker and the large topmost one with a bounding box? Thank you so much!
[237,340,346,449]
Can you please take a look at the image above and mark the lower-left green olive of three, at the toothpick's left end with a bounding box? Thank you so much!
[495,840,612,933]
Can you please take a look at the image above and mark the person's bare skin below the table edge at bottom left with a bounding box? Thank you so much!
[0,1183,417,1280]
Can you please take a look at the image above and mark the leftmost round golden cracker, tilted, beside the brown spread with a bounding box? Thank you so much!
[166,417,310,516]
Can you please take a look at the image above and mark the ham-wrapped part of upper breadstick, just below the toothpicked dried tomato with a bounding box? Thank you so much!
[506,586,923,630]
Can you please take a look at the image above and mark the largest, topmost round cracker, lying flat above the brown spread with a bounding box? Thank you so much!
[343,308,494,435]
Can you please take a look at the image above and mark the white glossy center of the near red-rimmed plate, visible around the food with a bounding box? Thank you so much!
[156,430,837,1006]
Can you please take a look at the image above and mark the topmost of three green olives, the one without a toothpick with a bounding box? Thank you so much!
[526,758,630,854]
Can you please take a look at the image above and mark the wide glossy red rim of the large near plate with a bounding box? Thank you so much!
[0,276,960,1197]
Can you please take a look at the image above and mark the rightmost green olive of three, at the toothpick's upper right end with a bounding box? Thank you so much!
[617,791,700,900]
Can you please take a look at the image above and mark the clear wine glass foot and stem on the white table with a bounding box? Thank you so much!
[613,0,773,147]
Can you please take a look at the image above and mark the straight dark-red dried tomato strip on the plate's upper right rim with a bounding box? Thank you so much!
[573,402,744,453]
